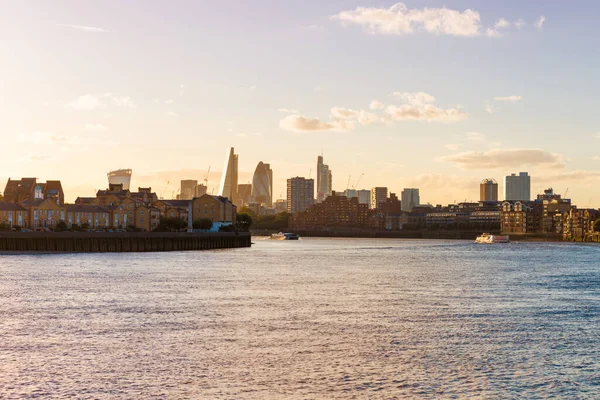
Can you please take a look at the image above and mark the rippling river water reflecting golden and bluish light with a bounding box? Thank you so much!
[0,239,600,399]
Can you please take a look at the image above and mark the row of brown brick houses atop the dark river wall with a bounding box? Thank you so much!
[0,178,237,231]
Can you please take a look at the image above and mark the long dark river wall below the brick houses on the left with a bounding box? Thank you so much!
[0,232,251,253]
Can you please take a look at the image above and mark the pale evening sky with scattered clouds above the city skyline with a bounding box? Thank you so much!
[0,0,600,208]
